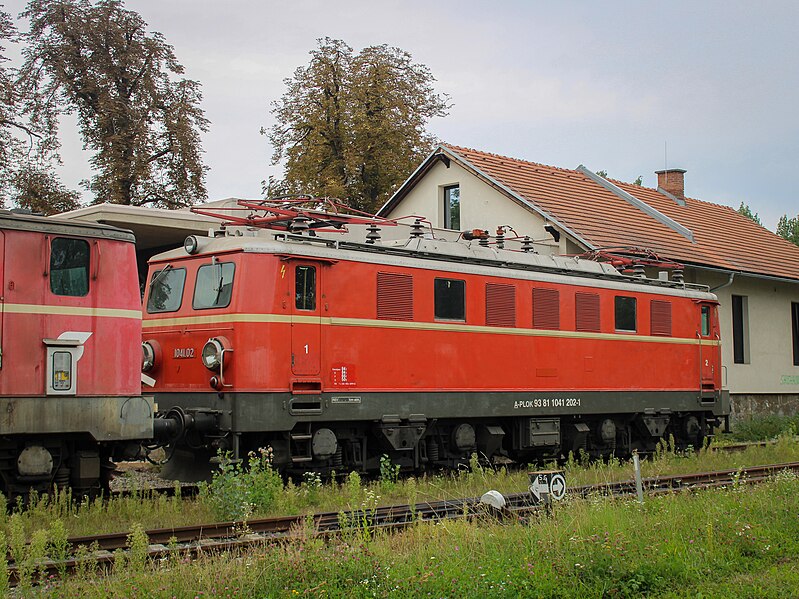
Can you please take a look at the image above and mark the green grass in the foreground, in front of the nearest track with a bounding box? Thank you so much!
[18,464,799,598]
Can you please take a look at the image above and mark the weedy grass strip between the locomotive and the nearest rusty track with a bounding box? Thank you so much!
[0,428,799,540]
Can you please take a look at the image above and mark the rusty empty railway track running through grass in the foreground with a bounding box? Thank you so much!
[8,462,799,585]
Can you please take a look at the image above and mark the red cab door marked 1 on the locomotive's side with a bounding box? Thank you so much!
[291,261,322,376]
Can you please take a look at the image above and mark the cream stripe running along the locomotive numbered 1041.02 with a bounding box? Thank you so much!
[142,314,720,345]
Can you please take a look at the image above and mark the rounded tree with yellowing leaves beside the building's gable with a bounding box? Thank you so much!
[262,38,449,211]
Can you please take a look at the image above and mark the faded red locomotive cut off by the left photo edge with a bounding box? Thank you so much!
[0,210,154,496]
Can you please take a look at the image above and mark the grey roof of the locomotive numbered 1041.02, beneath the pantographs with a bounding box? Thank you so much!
[152,228,715,299]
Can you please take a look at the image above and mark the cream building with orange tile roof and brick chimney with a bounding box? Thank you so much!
[379,145,799,413]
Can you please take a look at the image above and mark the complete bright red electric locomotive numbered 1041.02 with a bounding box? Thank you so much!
[143,202,729,475]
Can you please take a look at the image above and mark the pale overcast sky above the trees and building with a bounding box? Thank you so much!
[0,0,799,234]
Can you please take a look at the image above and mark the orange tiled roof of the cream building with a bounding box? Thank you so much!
[443,144,799,280]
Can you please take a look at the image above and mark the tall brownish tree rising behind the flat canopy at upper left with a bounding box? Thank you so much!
[21,0,208,208]
